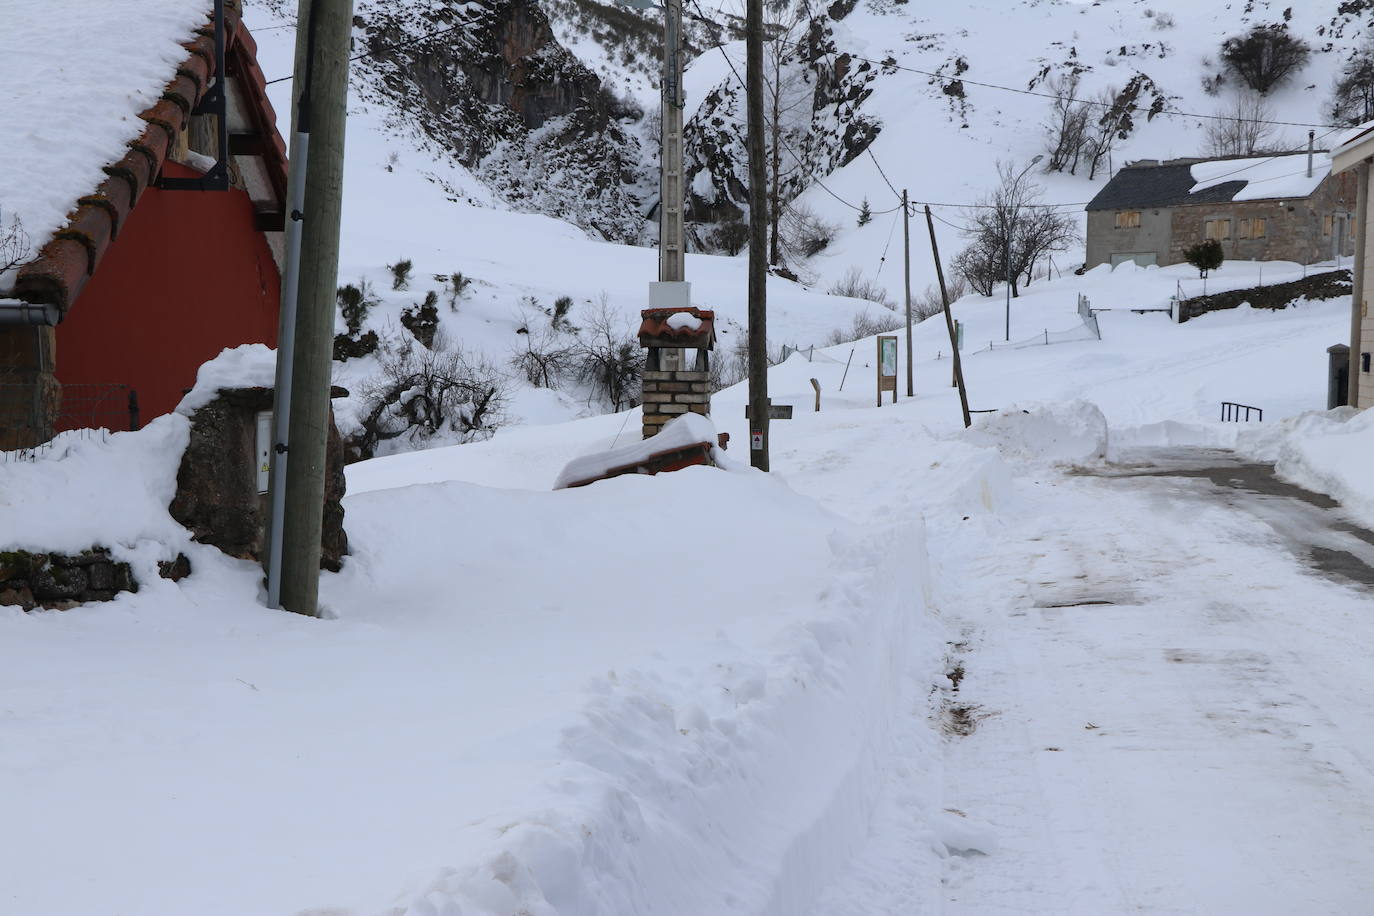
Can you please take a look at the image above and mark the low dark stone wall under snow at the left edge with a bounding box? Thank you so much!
[0,547,191,611]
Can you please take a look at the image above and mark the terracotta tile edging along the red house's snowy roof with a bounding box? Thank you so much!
[14,0,286,316]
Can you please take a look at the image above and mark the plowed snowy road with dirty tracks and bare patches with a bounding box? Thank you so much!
[890,453,1374,916]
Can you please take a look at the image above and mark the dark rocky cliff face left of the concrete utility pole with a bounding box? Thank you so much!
[354,0,643,242]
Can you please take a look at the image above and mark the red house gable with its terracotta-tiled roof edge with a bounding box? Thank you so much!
[14,0,287,428]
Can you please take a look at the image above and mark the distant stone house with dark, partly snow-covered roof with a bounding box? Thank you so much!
[1085,151,1355,268]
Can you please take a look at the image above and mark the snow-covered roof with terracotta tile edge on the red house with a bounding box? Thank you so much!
[0,0,286,314]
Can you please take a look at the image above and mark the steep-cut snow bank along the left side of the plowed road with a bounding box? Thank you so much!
[397,516,948,916]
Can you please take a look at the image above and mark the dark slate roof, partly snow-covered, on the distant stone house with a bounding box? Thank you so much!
[1087,152,1331,210]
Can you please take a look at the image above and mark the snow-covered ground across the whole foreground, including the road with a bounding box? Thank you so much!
[0,260,1374,916]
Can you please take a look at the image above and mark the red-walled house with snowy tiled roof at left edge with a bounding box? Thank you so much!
[0,0,287,449]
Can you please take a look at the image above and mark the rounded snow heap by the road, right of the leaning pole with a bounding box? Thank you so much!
[963,401,1107,464]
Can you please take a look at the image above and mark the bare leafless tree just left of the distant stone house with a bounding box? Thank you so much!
[954,162,1079,297]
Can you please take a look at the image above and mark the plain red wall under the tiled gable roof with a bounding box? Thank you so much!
[56,162,280,427]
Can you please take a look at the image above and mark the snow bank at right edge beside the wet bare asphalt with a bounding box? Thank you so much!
[1237,407,1374,525]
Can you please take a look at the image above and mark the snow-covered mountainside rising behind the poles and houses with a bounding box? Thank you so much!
[246,0,1367,453]
